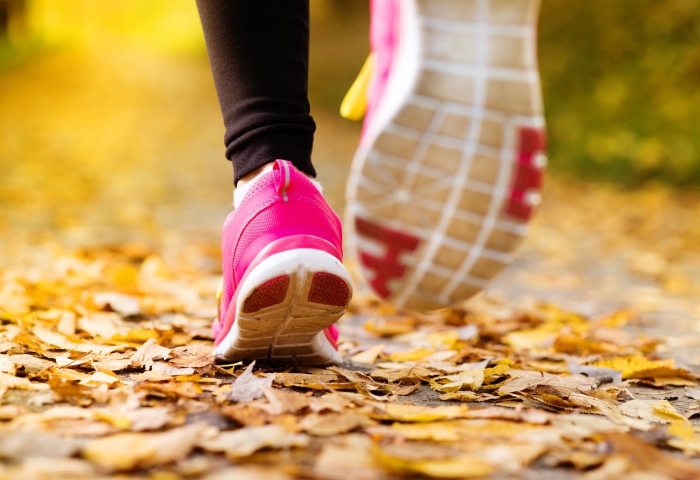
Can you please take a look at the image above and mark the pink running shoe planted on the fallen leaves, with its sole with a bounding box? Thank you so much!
[213,160,352,365]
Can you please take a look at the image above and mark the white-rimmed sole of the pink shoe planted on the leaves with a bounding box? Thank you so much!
[214,248,353,365]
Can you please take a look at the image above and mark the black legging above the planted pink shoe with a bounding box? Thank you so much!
[197,0,316,183]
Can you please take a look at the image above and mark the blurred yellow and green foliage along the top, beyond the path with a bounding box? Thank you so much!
[0,0,700,187]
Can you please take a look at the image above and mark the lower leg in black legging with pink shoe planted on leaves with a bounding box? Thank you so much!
[198,0,352,365]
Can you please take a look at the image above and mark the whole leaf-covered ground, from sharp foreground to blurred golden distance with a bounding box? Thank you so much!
[0,42,700,480]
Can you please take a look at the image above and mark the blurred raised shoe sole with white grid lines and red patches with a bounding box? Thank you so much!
[346,0,546,310]
